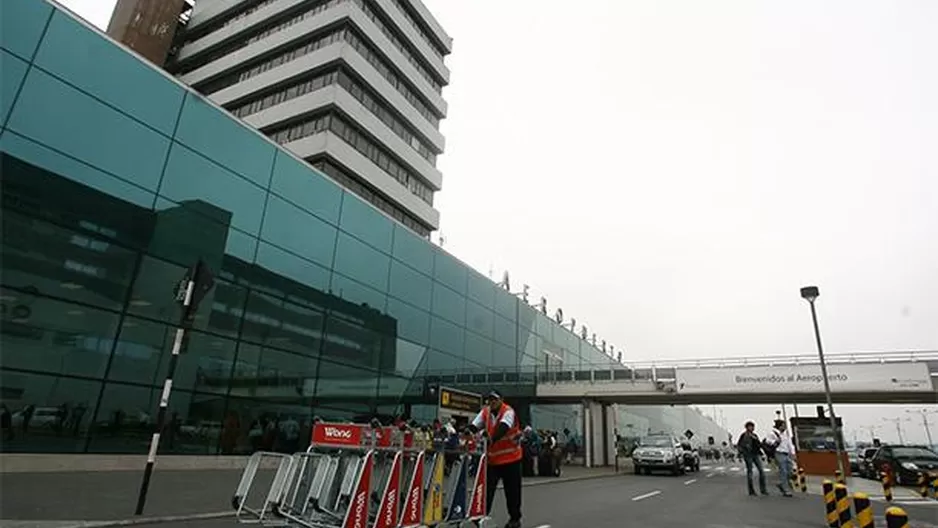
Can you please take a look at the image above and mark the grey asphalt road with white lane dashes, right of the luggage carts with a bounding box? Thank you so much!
[154,466,938,528]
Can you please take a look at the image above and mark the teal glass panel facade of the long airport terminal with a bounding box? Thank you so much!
[0,1,611,454]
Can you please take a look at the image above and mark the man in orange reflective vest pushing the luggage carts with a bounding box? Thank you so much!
[469,391,524,528]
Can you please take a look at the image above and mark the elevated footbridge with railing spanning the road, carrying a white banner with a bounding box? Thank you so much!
[535,351,938,405]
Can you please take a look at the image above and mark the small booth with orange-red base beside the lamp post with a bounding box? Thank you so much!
[791,417,850,477]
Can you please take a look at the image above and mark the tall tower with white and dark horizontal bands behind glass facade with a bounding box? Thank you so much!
[166,0,452,237]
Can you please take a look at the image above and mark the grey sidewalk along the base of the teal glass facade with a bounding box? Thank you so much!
[0,466,626,528]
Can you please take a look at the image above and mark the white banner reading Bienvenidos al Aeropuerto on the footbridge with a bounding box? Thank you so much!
[675,363,932,394]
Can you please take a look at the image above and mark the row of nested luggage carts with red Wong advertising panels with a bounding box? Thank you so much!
[232,423,488,528]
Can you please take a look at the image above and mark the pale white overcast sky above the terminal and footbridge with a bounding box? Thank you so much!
[63,0,938,446]
